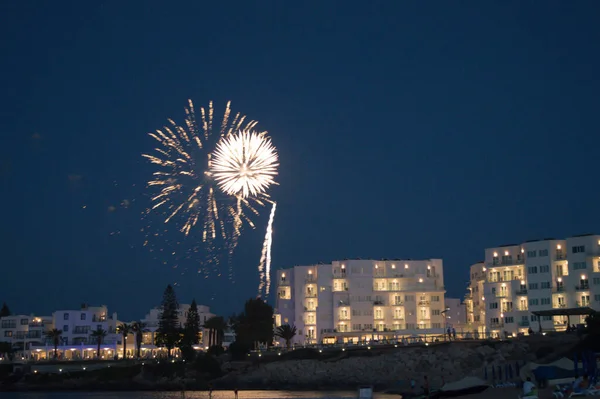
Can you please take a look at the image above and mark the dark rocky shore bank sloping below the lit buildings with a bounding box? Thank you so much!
[0,336,576,391]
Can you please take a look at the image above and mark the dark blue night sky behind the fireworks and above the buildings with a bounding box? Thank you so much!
[0,0,600,318]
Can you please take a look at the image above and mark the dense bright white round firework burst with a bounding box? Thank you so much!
[211,130,279,198]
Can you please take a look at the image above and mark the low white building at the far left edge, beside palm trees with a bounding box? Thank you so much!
[0,315,53,349]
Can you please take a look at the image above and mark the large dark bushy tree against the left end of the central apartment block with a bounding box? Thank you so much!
[233,298,273,348]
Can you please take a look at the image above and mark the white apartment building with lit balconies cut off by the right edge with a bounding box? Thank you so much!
[466,234,600,336]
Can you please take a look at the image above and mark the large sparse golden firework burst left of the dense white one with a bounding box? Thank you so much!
[143,101,262,242]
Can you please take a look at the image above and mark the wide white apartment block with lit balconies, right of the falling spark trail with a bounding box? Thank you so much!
[275,259,445,344]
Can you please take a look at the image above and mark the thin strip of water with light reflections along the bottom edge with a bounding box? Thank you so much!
[0,391,400,399]
